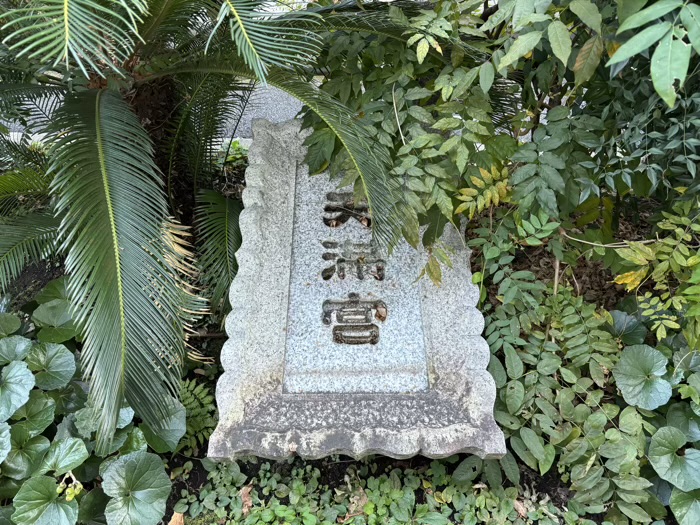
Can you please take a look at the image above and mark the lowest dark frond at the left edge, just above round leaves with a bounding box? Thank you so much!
[0,212,60,292]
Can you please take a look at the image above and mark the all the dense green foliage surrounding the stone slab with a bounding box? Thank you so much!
[0,0,700,525]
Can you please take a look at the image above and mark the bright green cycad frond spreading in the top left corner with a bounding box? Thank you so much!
[0,0,147,77]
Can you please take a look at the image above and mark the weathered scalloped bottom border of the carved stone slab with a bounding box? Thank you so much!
[209,392,506,459]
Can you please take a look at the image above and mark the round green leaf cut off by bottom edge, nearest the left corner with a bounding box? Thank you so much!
[12,476,78,525]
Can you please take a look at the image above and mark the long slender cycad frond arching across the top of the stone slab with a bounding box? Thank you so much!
[144,55,406,248]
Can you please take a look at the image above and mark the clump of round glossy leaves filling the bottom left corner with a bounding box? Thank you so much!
[0,278,184,525]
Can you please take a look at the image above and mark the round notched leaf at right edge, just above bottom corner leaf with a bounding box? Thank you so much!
[647,427,700,492]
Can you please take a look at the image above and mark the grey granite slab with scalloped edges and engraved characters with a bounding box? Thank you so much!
[209,120,506,459]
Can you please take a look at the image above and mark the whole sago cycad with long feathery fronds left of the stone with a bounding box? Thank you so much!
[0,0,416,448]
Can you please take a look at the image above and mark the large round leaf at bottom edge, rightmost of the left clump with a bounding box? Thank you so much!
[102,452,171,525]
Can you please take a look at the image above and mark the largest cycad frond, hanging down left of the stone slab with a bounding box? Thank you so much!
[52,90,191,450]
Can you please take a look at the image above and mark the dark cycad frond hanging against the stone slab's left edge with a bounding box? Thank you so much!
[195,190,243,315]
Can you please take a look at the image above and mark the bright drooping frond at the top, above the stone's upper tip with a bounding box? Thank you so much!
[212,0,321,84]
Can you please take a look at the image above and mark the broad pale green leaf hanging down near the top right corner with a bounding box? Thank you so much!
[651,33,691,107]
